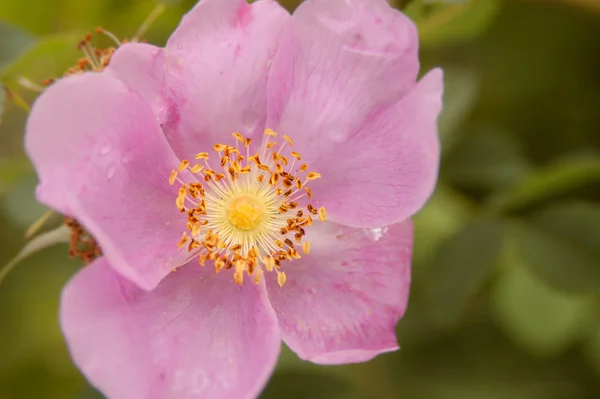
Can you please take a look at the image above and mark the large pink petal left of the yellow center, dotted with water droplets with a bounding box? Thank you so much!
[25,73,186,289]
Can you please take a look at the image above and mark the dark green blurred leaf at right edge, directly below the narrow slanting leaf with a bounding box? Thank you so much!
[511,203,600,293]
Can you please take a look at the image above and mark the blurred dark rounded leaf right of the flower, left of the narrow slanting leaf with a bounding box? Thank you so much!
[442,128,529,191]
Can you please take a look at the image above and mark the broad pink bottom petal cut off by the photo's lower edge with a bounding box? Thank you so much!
[60,258,280,399]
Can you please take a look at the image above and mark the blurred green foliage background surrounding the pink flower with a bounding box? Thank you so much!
[0,0,600,399]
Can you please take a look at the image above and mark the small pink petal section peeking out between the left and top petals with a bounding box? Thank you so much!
[107,43,168,123]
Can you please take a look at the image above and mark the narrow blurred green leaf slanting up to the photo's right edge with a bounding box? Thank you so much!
[489,155,600,212]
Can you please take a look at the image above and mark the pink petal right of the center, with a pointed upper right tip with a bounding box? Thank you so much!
[313,69,443,228]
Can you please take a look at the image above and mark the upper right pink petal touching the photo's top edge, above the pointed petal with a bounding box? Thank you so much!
[267,0,419,131]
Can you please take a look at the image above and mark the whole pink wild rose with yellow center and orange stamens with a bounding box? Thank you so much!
[26,0,442,399]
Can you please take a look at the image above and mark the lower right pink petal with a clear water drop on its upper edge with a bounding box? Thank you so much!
[267,221,413,364]
